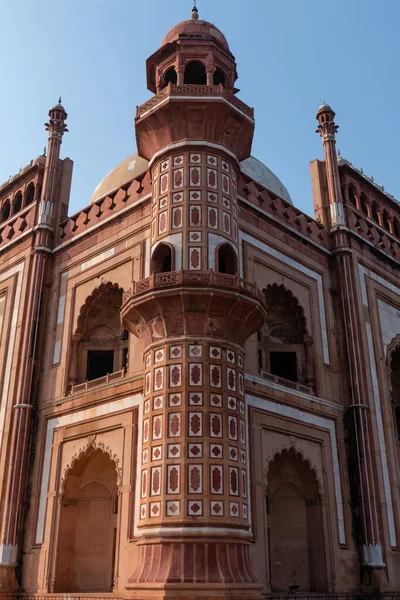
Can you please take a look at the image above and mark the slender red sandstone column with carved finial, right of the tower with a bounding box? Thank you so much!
[317,105,385,584]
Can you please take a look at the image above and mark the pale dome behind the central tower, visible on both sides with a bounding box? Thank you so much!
[90,152,292,204]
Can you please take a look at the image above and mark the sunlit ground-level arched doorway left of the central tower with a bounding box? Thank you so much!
[54,447,118,593]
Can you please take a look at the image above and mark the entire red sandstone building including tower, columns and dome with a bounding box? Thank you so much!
[0,7,400,600]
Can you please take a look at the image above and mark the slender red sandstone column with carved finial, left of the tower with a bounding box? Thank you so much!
[0,99,67,591]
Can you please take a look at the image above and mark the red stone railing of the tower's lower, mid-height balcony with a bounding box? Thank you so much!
[124,270,263,302]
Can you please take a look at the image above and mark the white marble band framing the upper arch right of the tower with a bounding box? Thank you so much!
[239,231,330,365]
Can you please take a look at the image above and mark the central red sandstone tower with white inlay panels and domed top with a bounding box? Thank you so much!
[122,10,265,600]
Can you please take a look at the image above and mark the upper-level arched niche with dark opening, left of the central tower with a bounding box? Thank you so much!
[69,283,129,385]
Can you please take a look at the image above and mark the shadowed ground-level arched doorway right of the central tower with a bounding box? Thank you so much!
[267,449,327,592]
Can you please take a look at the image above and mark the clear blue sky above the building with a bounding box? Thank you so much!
[0,0,400,214]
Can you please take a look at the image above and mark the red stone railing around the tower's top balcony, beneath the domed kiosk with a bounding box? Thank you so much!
[136,83,254,119]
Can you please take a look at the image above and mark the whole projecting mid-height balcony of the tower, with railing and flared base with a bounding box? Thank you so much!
[121,270,266,346]
